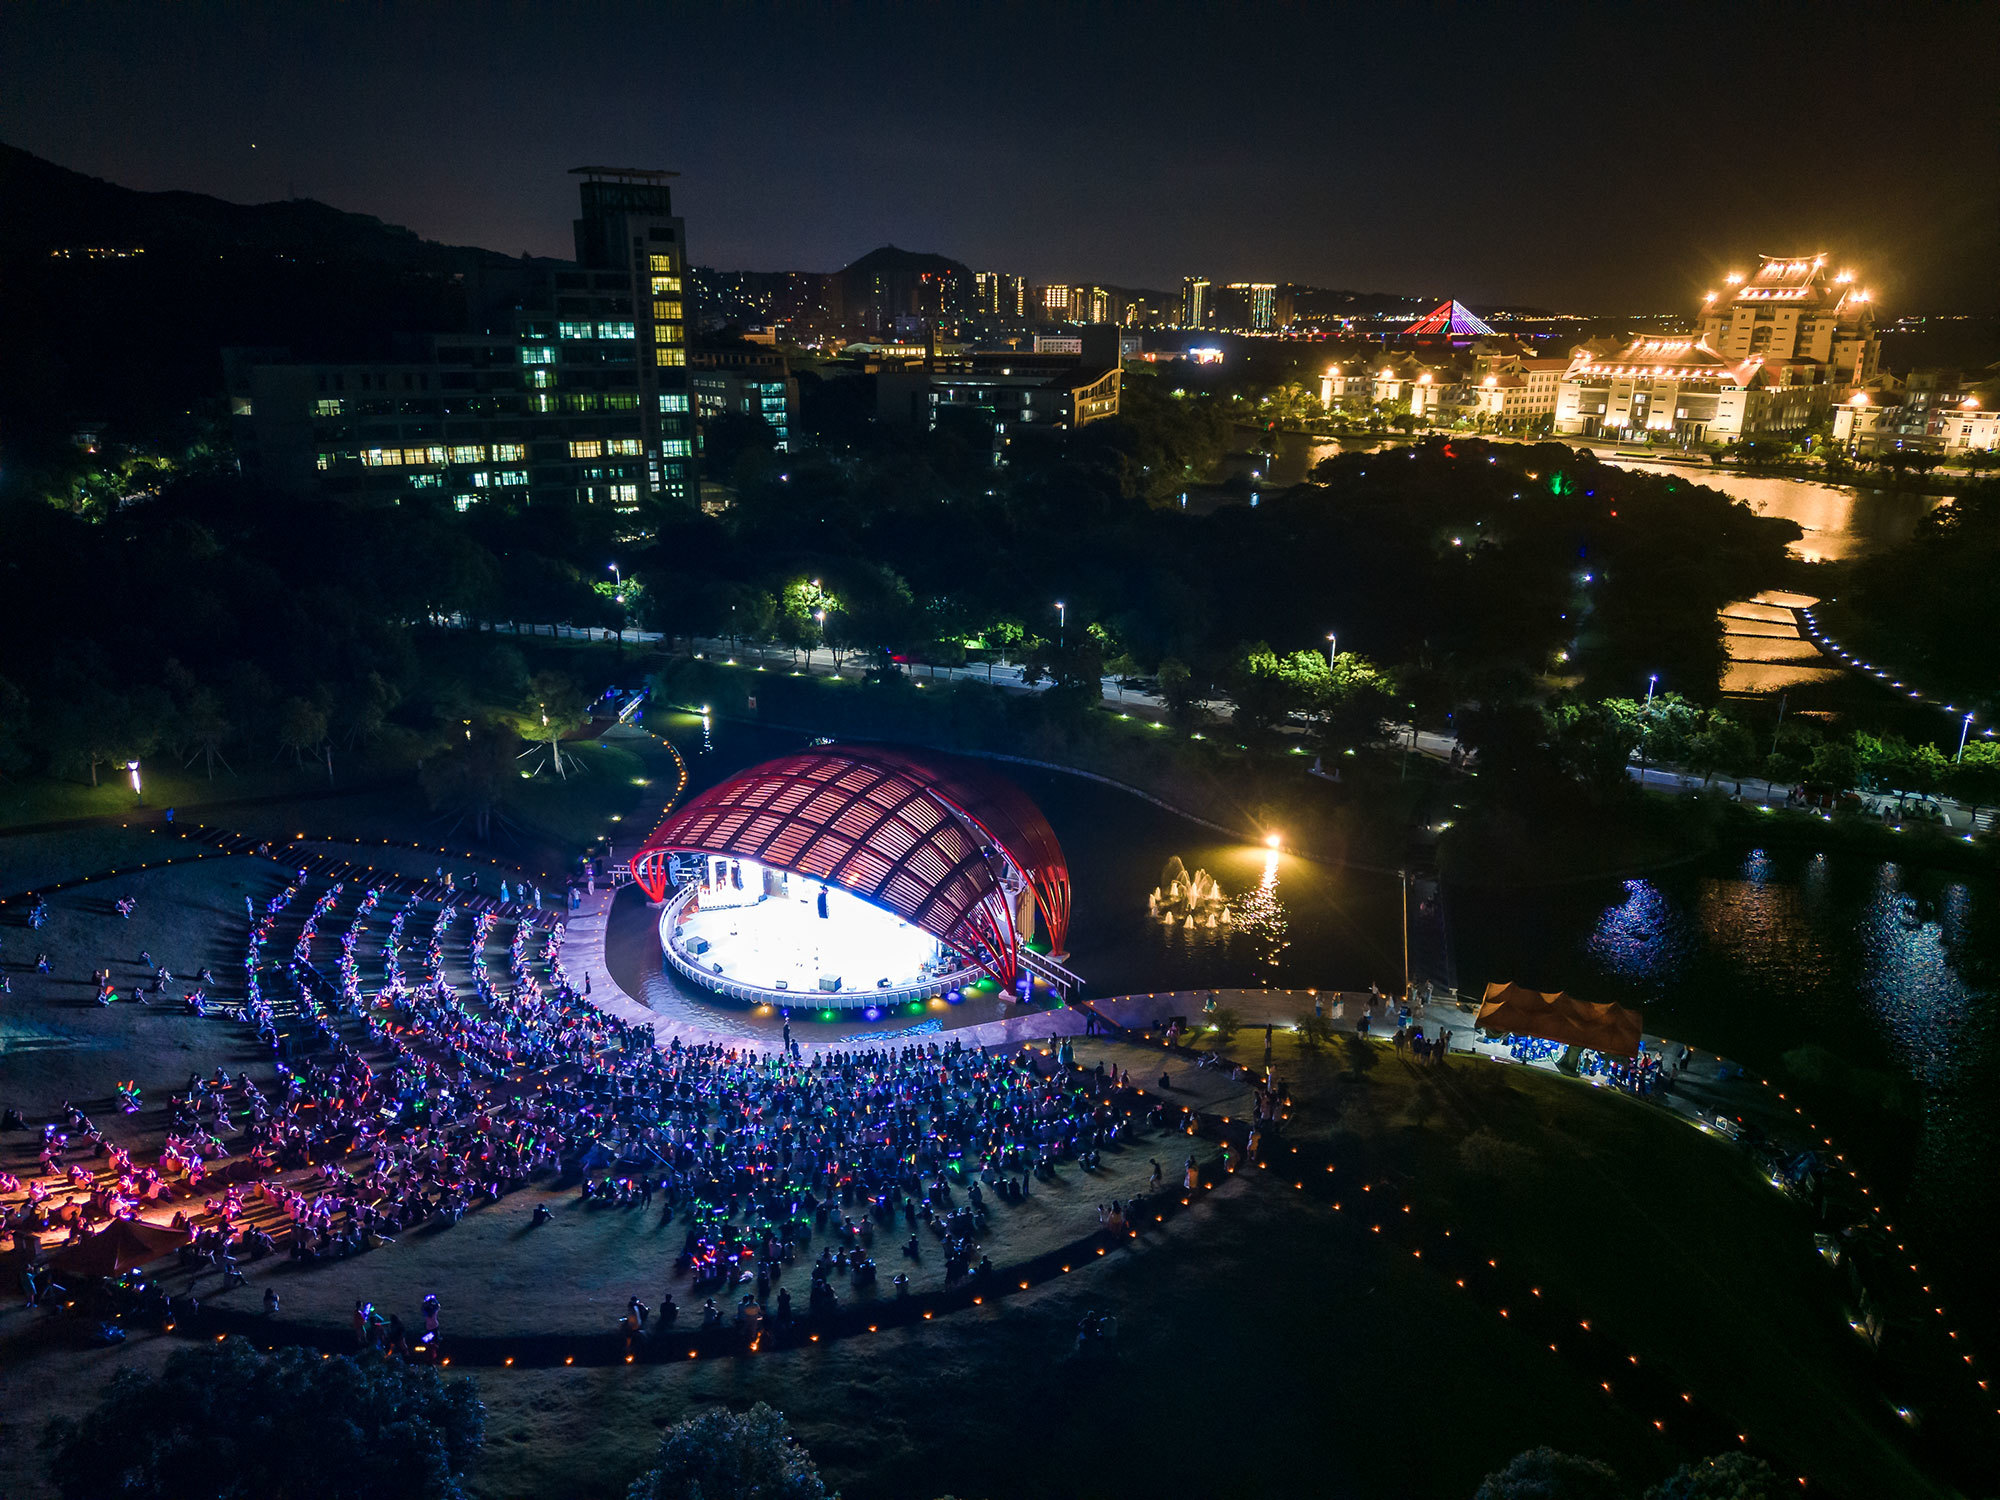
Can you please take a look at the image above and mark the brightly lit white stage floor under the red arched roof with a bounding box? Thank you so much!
[680,878,962,1002]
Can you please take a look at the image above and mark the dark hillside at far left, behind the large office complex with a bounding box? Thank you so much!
[0,146,510,468]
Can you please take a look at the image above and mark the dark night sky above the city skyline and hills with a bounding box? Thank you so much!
[0,0,2000,312]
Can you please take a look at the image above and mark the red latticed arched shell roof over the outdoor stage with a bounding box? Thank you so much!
[632,744,1070,984]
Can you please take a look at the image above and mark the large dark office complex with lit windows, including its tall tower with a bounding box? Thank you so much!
[224,168,698,524]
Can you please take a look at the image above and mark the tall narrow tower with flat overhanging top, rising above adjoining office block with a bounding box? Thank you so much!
[570,166,700,502]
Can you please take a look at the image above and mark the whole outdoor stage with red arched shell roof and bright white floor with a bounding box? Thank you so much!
[632,744,1076,1016]
